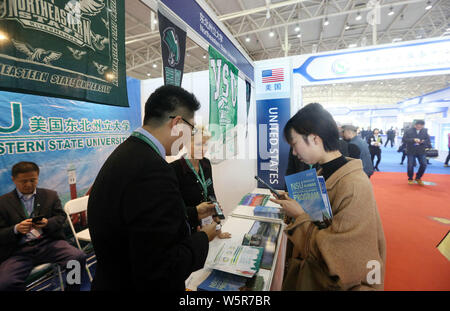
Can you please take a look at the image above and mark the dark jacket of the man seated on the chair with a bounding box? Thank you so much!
[0,188,67,263]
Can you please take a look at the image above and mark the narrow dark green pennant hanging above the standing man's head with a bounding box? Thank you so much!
[158,11,186,86]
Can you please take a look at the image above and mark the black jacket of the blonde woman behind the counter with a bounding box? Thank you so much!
[170,158,216,232]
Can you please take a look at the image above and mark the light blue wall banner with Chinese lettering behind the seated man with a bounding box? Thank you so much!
[0,78,142,204]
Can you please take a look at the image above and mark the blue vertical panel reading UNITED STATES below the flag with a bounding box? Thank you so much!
[256,98,291,190]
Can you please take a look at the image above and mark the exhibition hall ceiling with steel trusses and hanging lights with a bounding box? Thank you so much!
[125,0,450,97]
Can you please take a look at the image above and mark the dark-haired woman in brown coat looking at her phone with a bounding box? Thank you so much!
[271,103,386,290]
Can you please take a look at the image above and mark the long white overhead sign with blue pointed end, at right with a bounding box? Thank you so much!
[293,39,450,85]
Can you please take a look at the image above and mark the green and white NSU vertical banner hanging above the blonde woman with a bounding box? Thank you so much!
[208,46,239,160]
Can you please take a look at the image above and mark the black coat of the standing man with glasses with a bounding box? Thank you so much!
[88,136,209,291]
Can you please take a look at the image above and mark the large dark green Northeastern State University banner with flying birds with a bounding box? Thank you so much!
[0,0,129,107]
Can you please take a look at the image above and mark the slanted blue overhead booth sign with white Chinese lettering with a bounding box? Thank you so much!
[161,0,253,81]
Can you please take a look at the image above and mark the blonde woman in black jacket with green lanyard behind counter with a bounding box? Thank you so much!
[170,126,231,239]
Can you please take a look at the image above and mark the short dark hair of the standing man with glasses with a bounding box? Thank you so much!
[144,85,200,126]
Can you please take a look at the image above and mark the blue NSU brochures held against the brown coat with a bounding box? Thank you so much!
[285,169,333,228]
